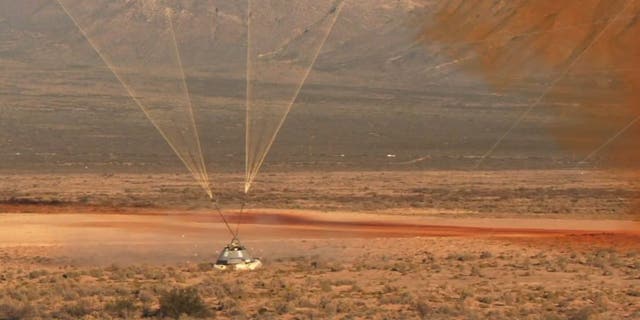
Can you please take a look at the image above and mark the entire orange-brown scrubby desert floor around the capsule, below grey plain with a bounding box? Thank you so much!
[0,170,640,319]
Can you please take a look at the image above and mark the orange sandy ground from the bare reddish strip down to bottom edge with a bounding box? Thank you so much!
[0,206,640,319]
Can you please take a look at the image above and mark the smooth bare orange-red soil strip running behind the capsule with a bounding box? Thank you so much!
[0,206,640,250]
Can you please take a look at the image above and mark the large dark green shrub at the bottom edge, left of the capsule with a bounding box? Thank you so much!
[158,288,210,319]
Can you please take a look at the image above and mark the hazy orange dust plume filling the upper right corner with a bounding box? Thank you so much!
[420,0,640,212]
